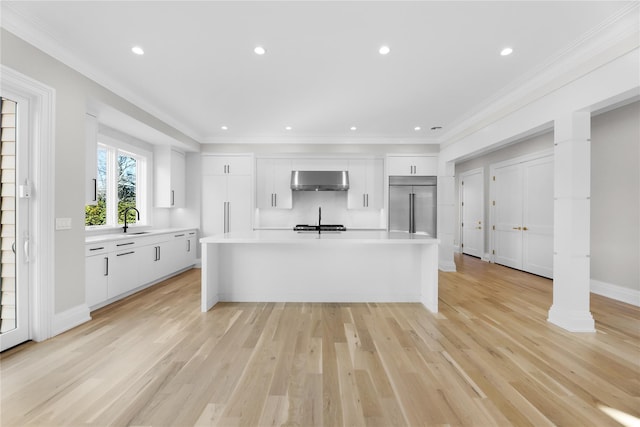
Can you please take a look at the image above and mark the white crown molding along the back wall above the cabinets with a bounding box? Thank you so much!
[202,136,439,145]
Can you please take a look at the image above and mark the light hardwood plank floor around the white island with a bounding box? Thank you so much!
[0,256,640,426]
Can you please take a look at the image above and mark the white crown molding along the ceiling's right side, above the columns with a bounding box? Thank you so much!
[439,2,640,150]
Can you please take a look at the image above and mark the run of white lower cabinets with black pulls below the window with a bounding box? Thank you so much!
[85,230,197,308]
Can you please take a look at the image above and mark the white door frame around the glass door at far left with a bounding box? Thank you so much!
[0,64,55,341]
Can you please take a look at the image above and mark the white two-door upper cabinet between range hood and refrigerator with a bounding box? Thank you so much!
[347,159,384,210]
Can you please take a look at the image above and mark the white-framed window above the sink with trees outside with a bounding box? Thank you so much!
[85,137,147,227]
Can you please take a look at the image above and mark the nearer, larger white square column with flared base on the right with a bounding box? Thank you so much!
[548,112,595,332]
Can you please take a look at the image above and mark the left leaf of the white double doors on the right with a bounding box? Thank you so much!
[491,164,522,270]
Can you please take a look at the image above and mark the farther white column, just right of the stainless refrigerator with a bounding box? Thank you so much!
[438,162,456,271]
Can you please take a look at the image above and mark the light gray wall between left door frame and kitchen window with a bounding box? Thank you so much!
[0,29,195,313]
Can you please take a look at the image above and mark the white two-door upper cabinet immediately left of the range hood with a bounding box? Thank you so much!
[256,159,293,209]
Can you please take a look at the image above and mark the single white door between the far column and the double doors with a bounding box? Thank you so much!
[460,169,484,258]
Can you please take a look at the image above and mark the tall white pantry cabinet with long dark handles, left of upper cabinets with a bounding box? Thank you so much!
[202,154,253,237]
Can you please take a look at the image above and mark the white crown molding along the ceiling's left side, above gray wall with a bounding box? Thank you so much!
[0,2,201,141]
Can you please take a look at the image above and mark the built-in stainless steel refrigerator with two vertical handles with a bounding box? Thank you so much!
[389,176,437,237]
